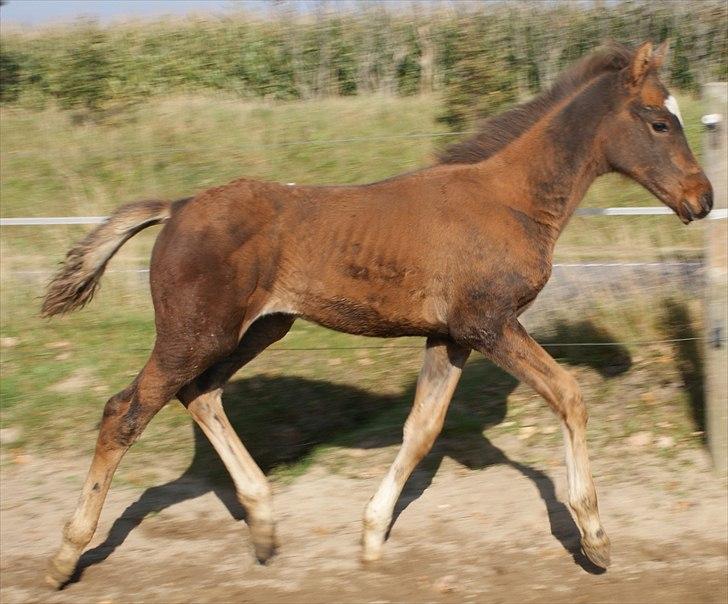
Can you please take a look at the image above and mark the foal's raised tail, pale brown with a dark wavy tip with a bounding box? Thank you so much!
[41,201,172,317]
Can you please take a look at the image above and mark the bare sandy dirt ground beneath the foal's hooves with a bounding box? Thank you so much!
[0,436,728,604]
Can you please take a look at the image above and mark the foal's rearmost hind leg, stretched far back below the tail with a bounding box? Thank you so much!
[46,353,192,587]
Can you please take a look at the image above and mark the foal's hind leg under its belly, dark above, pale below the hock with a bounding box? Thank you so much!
[178,315,295,562]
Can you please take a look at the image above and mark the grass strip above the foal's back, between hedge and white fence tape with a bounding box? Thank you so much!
[0,97,443,215]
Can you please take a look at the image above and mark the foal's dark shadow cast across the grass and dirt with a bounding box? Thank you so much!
[71,322,631,582]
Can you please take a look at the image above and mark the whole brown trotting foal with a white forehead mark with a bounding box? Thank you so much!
[43,43,712,587]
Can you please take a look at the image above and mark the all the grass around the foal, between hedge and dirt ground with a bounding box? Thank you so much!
[0,92,702,480]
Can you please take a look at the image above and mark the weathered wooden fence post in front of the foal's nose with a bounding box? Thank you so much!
[703,82,728,476]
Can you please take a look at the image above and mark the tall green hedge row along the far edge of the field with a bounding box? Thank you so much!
[0,0,728,127]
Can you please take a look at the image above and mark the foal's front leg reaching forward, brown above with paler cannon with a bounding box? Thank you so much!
[477,319,610,568]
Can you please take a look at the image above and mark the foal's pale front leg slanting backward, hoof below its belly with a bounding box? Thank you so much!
[362,339,470,561]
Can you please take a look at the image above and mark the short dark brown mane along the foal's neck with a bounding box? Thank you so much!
[437,43,633,164]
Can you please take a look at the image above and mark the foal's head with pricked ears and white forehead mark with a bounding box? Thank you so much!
[605,42,713,224]
